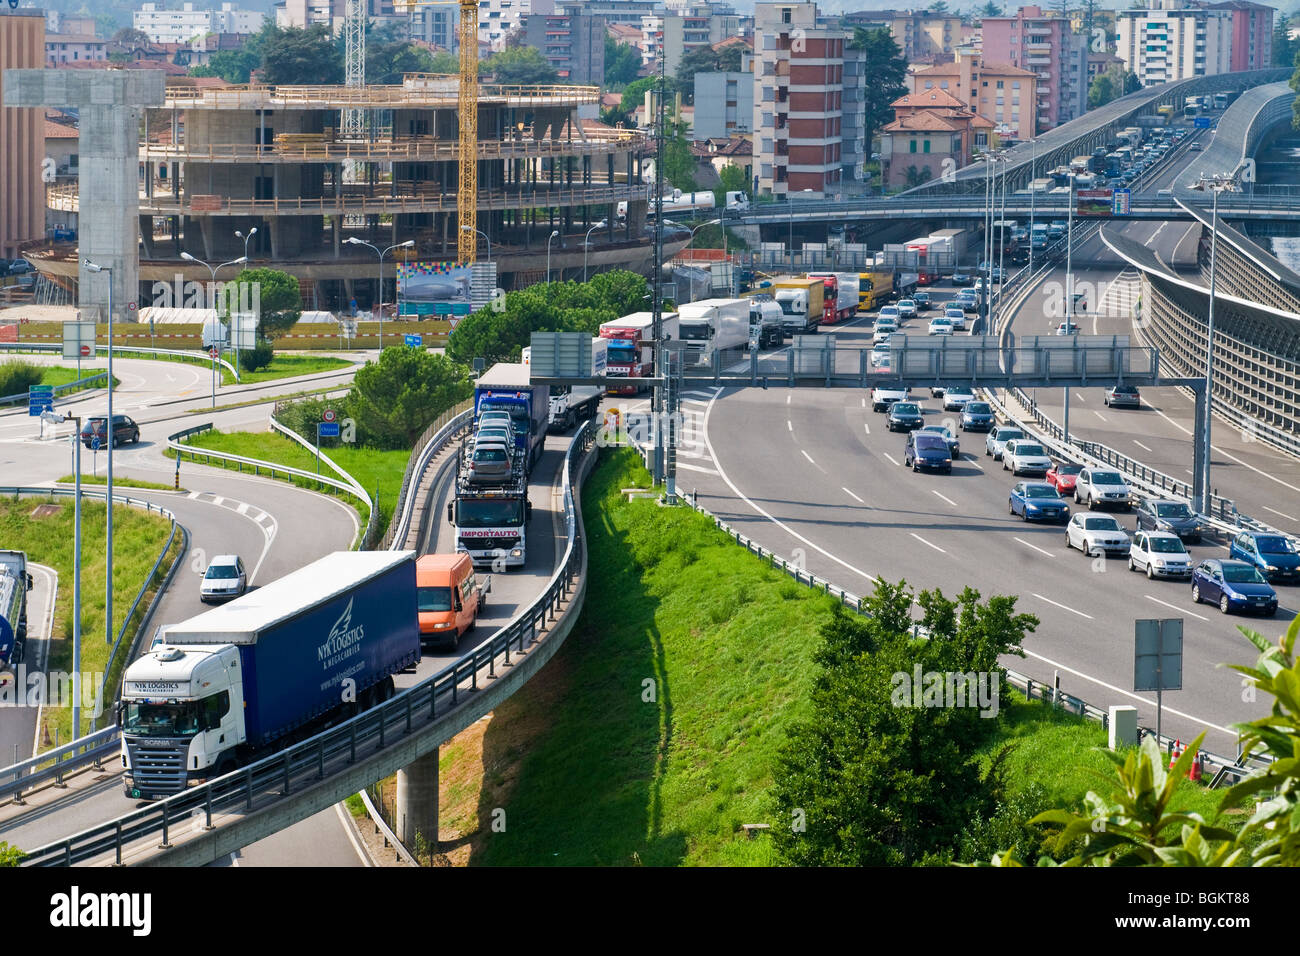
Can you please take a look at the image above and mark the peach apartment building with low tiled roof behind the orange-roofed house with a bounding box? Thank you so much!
[907,48,1039,142]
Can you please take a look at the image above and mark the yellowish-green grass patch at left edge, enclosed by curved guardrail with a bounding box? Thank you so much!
[0,497,182,750]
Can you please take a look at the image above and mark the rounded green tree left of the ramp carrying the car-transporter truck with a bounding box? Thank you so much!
[348,346,473,449]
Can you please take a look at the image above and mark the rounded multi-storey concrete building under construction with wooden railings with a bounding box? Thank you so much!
[32,74,689,308]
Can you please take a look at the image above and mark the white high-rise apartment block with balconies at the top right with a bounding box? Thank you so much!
[1115,0,1232,86]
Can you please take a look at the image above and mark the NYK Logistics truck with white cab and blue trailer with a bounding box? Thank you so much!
[117,551,420,800]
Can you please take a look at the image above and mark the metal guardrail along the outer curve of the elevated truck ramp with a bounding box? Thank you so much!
[15,421,597,866]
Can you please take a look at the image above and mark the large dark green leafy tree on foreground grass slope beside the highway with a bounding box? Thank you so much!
[772,581,1037,865]
